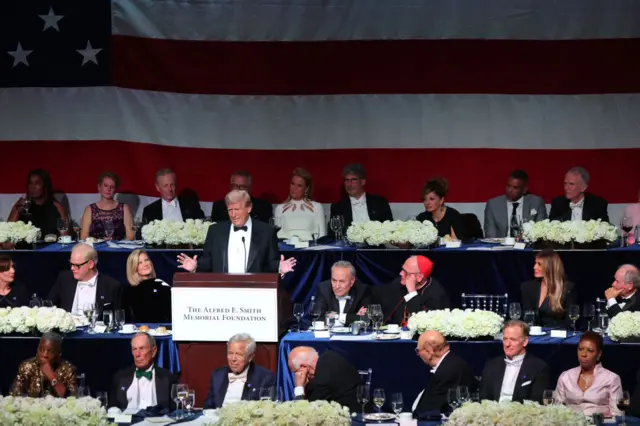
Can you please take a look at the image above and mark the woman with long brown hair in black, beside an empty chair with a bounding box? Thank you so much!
[520,250,575,327]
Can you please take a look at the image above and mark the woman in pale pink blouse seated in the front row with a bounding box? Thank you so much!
[554,331,622,417]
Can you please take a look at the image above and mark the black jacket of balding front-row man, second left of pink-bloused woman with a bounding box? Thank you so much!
[414,352,476,413]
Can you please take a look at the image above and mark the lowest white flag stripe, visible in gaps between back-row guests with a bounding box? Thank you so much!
[0,194,626,233]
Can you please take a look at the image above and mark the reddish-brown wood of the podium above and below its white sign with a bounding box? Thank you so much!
[172,272,291,407]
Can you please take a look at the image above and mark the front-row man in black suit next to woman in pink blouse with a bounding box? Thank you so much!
[480,320,549,402]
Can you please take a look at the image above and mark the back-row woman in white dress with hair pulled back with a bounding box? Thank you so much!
[275,167,327,241]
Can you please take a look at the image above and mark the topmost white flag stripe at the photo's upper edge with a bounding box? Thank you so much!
[112,0,640,41]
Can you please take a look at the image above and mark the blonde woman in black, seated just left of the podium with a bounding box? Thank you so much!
[124,250,171,323]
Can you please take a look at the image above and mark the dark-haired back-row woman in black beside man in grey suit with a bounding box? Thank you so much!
[416,177,463,239]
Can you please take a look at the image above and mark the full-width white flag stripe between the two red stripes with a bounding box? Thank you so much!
[0,87,640,150]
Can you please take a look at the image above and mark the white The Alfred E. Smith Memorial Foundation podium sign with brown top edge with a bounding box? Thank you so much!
[171,274,278,342]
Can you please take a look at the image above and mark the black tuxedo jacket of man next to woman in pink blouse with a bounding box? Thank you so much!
[480,352,549,403]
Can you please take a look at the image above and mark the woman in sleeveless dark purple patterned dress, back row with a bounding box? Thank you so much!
[80,172,135,240]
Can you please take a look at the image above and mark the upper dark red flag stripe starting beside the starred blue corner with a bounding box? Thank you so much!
[112,36,640,95]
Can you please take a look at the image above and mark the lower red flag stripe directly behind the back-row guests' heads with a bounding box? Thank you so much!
[0,141,640,203]
